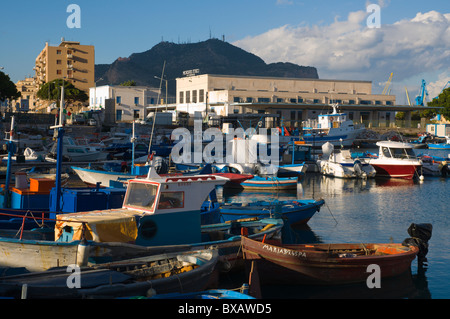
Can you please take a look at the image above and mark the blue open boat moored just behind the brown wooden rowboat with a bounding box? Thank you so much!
[220,199,325,225]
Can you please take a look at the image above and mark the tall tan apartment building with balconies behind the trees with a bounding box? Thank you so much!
[34,38,95,112]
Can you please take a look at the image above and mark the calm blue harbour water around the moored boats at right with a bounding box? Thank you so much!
[217,149,450,299]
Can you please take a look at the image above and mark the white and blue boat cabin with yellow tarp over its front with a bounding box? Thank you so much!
[55,173,229,246]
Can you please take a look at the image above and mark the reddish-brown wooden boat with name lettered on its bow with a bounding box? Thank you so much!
[242,237,419,285]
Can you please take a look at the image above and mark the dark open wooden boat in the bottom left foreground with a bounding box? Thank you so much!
[0,248,219,298]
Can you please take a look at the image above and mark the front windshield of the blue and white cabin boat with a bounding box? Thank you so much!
[123,182,158,210]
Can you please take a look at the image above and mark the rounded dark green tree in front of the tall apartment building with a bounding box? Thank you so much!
[36,79,89,103]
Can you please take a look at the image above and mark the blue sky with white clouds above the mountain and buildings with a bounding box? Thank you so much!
[0,0,450,103]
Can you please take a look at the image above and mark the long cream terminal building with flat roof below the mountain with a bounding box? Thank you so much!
[176,74,396,126]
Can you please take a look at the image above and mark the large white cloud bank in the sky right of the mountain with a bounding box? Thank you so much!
[234,10,450,97]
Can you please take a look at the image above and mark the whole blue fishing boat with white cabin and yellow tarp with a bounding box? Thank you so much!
[0,170,283,271]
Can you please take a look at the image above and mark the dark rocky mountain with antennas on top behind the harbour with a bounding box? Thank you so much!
[95,39,319,95]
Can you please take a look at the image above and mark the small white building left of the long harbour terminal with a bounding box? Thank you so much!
[89,85,162,122]
